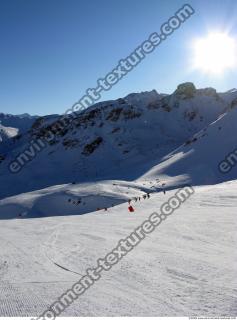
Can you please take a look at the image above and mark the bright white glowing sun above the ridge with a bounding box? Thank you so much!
[193,33,237,74]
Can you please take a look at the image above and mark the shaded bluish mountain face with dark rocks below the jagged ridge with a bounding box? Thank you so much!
[0,83,237,198]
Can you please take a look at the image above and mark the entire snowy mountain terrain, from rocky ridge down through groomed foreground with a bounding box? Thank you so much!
[0,83,237,317]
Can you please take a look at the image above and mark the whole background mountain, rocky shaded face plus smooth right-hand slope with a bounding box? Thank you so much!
[0,83,237,215]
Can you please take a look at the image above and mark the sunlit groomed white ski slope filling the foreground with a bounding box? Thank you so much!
[0,181,237,317]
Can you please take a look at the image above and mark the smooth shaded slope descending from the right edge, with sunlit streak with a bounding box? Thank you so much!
[143,107,237,186]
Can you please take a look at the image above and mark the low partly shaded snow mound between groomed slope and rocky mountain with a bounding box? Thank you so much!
[0,180,168,219]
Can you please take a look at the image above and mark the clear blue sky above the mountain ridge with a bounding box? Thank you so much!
[0,0,237,115]
